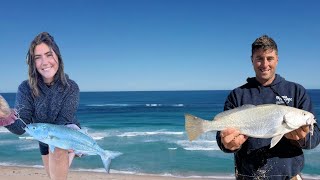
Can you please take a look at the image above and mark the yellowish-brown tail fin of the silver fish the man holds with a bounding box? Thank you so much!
[185,114,211,141]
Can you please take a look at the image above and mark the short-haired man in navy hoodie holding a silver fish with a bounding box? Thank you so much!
[217,35,320,179]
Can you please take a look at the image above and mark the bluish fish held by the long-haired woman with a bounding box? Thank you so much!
[25,123,121,173]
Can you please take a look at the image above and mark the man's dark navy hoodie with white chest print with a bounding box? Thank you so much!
[217,75,320,179]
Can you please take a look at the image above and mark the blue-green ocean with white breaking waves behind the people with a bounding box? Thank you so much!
[0,90,320,178]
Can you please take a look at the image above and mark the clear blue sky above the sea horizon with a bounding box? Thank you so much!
[0,0,320,93]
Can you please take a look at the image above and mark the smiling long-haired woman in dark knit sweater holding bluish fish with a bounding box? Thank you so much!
[5,32,80,179]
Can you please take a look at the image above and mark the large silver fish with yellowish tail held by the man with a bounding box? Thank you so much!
[185,104,316,148]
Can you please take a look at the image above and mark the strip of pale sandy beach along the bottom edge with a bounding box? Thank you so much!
[0,166,233,180]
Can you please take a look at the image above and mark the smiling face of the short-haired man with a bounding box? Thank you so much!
[251,49,278,86]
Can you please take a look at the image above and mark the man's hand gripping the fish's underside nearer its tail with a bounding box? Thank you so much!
[220,128,248,151]
